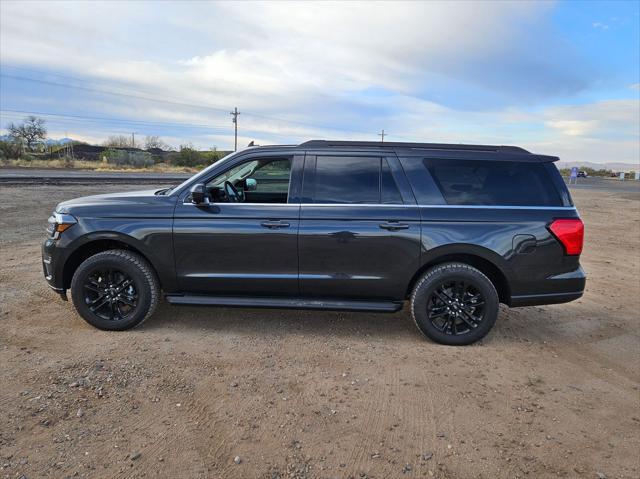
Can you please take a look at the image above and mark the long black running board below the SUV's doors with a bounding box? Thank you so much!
[165,294,402,313]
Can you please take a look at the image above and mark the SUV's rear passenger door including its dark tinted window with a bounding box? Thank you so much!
[298,153,420,299]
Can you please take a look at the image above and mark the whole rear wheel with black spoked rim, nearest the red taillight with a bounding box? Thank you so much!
[411,263,499,346]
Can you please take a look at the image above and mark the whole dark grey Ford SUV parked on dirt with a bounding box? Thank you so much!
[42,140,585,345]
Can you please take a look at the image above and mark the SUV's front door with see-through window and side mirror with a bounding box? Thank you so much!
[174,157,302,296]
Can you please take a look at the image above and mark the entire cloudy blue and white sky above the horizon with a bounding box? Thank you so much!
[0,0,640,163]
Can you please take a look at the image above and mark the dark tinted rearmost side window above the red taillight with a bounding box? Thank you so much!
[424,159,562,206]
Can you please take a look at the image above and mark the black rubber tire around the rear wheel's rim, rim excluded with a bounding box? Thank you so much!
[411,265,499,345]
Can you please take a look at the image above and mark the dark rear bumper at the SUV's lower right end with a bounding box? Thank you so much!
[509,266,587,308]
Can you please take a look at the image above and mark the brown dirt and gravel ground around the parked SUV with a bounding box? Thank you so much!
[0,185,640,479]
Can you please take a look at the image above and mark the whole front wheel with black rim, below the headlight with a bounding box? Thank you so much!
[71,249,160,331]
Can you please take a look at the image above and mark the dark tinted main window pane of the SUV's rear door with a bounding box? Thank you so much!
[314,156,380,203]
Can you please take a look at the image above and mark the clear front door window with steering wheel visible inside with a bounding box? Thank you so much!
[207,158,291,203]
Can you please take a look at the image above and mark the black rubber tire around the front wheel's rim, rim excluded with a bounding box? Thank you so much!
[71,252,152,331]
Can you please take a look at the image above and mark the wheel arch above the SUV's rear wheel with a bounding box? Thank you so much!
[406,244,511,304]
